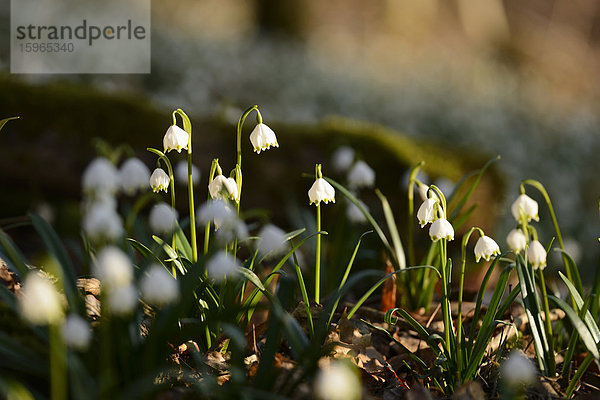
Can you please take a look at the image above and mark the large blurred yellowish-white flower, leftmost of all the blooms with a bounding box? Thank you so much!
[19,271,64,325]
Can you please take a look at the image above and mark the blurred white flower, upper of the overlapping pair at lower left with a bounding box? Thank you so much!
[92,246,133,290]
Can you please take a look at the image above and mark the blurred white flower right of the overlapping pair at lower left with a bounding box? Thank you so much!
[140,264,179,306]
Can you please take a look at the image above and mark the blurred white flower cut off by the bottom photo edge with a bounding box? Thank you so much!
[314,361,362,400]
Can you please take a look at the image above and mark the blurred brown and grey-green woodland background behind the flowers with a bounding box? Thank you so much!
[0,0,600,278]
